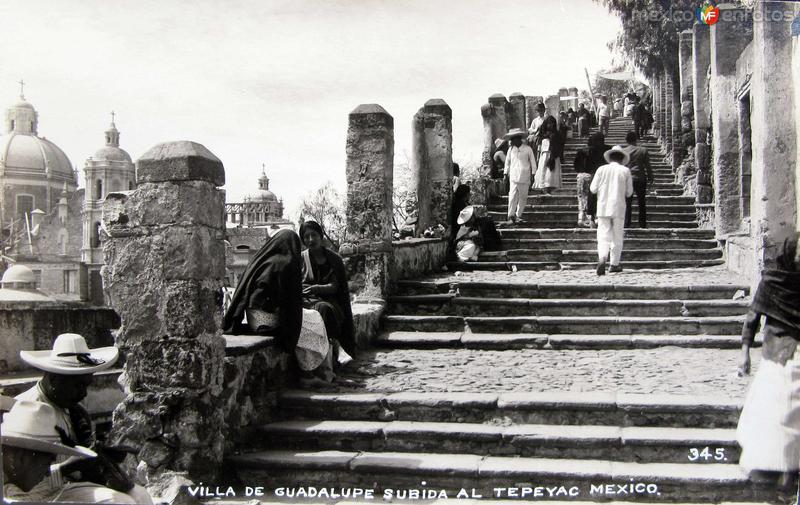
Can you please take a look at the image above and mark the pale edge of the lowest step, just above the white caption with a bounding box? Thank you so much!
[226,451,750,486]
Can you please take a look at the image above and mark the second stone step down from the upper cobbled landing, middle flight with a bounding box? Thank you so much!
[389,294,750,317]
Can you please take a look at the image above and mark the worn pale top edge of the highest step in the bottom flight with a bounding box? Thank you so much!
[278,390,744,415]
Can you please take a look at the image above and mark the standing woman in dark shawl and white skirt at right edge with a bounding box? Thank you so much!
[736,233,800,503]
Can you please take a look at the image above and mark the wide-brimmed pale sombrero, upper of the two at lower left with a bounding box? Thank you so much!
[19,333,119,375]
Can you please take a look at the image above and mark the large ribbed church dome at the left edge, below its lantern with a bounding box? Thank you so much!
[0,132,75,181]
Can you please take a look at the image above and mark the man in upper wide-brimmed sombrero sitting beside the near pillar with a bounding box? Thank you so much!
[17,333,153,504]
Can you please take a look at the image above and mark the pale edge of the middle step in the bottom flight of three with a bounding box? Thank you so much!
[257,420,738,446]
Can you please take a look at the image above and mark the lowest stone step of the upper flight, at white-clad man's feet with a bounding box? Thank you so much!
[447,258,725,275]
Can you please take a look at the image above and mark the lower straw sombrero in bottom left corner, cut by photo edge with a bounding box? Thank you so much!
[0,400,97,458]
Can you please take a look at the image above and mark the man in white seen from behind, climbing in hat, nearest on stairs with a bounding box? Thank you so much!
[589,146,633,275]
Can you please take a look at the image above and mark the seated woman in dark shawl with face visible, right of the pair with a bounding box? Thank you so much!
[300,221,356,355]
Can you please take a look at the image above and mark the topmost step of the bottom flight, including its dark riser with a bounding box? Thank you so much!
[278,388,744,428]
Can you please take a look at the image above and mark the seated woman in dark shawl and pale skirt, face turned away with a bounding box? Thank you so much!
[222,229,334,384]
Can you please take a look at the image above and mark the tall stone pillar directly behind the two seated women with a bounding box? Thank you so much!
[339,104,394,300]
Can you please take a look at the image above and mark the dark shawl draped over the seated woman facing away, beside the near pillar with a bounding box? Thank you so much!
[222,230,303,351]
